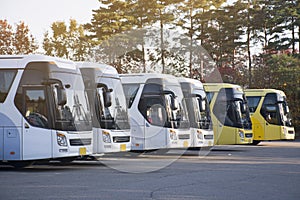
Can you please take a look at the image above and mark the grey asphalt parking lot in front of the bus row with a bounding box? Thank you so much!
[0,141,300,200]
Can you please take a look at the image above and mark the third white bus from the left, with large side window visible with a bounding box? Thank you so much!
[120,74,191,150]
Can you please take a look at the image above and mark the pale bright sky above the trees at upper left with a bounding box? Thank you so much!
[0,0,100,44]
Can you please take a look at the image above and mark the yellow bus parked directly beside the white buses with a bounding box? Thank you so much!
[203,83,253,145]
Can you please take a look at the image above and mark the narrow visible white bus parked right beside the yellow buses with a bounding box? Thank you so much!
[178,78,214,147]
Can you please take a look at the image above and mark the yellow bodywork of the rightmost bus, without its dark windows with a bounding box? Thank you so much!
[245,89,295,141]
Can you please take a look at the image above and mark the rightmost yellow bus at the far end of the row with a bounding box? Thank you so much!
[245,89,295,144]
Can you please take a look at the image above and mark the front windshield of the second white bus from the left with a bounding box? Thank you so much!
[96,77,130,130]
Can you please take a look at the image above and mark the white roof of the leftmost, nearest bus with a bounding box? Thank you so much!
[0,54,77,70]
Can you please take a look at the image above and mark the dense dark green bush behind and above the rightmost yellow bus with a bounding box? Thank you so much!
[253,54,300,128]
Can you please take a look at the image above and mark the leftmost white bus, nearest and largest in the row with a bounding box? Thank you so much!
[0,55,93,166]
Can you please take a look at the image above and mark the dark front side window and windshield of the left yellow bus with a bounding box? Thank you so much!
[213,88,252,129]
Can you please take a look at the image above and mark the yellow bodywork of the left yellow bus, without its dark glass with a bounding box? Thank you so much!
[203,83,253,145]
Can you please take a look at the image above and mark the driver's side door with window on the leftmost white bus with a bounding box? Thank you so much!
[22,86,53,159]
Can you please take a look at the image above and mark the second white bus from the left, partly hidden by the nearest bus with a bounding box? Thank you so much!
[77,62,131,154]
